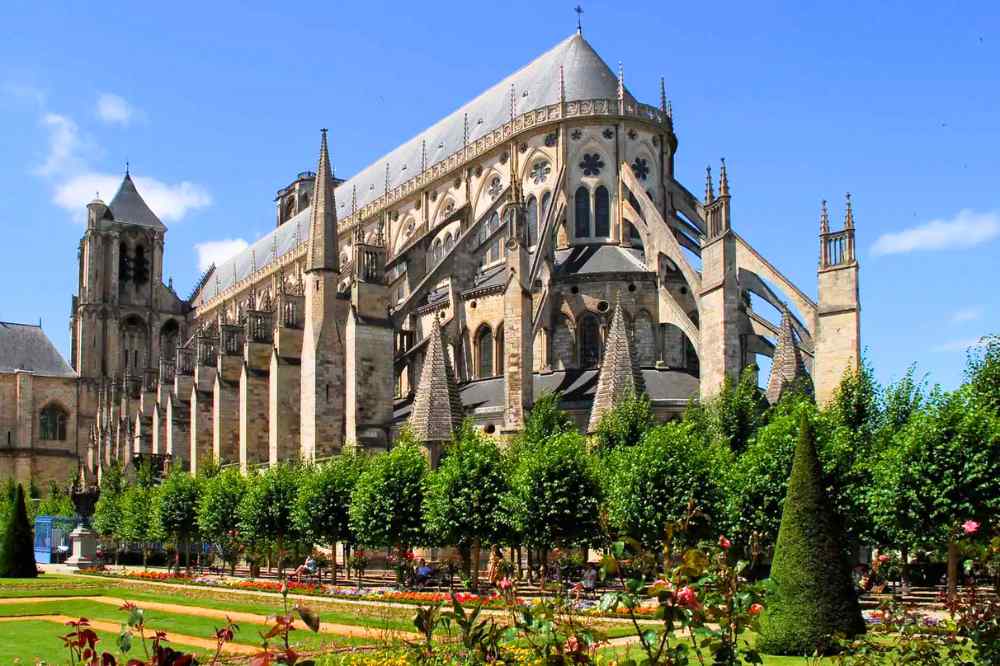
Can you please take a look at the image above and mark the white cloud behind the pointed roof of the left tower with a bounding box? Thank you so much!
[53,171,212,222]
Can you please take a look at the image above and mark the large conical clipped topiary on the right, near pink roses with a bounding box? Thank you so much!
[757,414,865,655]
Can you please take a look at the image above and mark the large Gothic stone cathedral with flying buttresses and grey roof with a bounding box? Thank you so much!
[0,31,860,474]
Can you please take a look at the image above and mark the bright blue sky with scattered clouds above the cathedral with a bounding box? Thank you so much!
[0,1,1000,387]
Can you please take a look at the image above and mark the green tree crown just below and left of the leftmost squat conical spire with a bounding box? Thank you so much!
[350,435,427,547]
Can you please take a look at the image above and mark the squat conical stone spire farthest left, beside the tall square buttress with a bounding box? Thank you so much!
[410,317,463,443]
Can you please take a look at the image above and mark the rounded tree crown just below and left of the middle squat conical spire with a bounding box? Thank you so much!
[505,432,601,549]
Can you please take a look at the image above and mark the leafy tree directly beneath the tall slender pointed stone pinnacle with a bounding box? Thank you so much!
[292,453,365,582]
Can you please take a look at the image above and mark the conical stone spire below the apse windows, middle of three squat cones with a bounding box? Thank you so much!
[587,298,646,432]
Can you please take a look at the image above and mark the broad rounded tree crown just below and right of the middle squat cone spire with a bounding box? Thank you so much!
[606,423,718,549]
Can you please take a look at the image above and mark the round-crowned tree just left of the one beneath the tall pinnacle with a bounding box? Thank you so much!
[239,463,302,576]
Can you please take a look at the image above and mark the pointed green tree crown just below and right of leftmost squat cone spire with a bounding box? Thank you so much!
[424,421,507,546]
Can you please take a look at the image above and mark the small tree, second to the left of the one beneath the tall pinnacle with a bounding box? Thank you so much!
[198,468,247,573]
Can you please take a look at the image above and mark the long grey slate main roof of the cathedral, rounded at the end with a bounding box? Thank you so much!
[196,33,635,299]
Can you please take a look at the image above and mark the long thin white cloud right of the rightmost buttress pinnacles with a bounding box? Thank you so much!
[872,209,1000,255]
